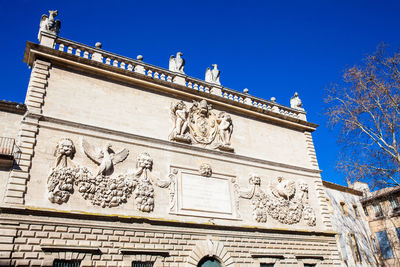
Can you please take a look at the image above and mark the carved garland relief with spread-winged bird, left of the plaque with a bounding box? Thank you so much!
[47,138,162,212]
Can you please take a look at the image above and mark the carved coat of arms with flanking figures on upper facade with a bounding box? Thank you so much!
[169,100,233,151]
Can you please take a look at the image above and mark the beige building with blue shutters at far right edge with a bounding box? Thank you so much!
[361,187,400,266]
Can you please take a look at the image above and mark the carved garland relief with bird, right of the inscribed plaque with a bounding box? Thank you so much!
[240,175,316,226]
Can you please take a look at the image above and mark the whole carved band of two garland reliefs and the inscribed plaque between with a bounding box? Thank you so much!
[47,139,316,226]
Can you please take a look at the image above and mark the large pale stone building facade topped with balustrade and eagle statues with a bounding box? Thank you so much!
[0,11,341,266]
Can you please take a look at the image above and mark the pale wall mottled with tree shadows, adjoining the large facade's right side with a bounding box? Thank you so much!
[323,181,378,267]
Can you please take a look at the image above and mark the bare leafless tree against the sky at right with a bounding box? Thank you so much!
[326,45,400,188]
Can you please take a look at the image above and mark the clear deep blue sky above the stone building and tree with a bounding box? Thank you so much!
[0,0,400,187]
